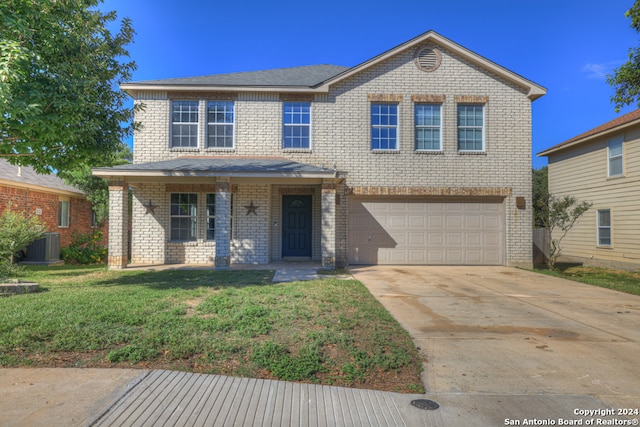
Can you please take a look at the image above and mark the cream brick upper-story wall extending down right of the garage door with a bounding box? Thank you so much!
[134,41,532,266]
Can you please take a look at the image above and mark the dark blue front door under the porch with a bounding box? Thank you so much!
[282,196,311,257]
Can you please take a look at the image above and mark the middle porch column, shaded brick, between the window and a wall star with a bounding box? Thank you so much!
[215,178,231,270]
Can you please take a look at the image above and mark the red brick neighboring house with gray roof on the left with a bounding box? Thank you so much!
[0,159,102,247]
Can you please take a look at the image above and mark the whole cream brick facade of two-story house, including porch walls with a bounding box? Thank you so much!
[120,40,532,267]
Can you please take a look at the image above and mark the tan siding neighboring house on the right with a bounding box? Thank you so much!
[538,110,640,268]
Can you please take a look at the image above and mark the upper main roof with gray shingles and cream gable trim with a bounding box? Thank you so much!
[122,30,547,101]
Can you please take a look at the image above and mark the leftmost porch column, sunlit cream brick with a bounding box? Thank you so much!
[107,181,129,270]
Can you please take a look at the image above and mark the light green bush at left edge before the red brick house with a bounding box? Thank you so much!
[0,205,46,277]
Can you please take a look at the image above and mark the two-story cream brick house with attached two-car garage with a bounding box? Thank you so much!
[94,31,546,268]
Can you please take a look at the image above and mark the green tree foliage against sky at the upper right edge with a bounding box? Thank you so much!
[607,0,640,112]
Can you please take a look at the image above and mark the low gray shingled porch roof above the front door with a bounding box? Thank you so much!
[94,156,335,176]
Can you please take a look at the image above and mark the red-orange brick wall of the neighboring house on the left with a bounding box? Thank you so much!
[0,186,108,247]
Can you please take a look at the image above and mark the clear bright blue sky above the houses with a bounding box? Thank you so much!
[101,0,640,168]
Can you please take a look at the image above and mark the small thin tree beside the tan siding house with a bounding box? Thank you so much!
[542,194,592,270]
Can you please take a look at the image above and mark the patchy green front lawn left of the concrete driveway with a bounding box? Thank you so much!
[0,266,424,393]
